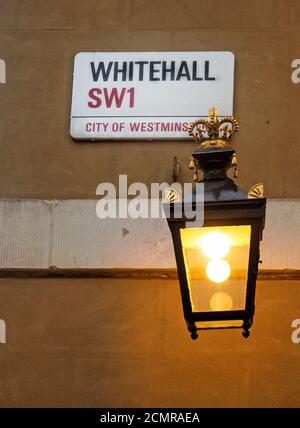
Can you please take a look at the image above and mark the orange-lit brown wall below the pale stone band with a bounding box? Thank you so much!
[0,279,300,407]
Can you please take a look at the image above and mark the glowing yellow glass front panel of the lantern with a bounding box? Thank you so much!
[180,225,251,314]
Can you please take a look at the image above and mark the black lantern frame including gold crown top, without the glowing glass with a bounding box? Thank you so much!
[165,108,266,339]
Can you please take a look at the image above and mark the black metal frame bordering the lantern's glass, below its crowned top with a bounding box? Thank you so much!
[168,198,266,339]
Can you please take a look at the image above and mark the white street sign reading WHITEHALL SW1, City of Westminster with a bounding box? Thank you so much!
[70,52,234,140]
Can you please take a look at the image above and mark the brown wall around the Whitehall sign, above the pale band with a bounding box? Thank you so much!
[0,0,300,199]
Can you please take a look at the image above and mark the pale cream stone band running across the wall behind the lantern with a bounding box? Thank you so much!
[0,199,300,269]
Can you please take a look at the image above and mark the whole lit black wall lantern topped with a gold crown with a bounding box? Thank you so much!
[167,108,266,339]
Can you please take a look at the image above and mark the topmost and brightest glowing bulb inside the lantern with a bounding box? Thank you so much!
[200,232,232,259]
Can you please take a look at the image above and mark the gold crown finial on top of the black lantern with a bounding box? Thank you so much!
[188,107,239,148]
